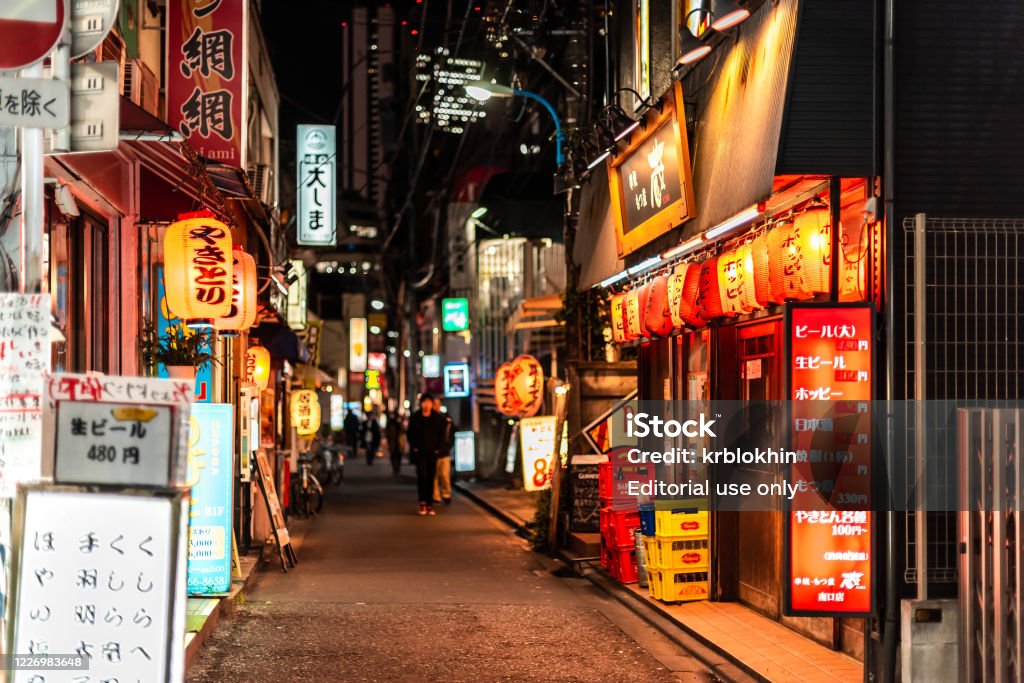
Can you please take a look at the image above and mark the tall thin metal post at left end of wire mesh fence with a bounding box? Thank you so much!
[913,213,928,600]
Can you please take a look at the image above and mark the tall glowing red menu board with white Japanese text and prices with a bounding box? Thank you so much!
[785,303,874,616]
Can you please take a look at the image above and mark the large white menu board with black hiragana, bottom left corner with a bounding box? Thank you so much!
[8,486,185,683]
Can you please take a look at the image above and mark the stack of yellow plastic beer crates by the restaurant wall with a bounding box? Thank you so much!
[641,501,711,602]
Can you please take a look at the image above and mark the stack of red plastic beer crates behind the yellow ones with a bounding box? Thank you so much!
[598,458,654,584]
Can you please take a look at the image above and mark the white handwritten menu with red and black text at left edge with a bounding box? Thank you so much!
[0,294,50,498]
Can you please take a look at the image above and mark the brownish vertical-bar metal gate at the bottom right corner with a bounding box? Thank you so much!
[957,409,1024,683]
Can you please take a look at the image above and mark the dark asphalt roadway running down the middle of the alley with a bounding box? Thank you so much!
[189,462,745,683]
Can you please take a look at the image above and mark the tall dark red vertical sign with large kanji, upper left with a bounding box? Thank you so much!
[167,0,249,169]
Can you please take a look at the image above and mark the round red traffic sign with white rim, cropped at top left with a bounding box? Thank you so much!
[0,0,68,71]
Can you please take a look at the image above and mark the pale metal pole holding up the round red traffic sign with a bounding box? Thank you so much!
[18,65,43,293]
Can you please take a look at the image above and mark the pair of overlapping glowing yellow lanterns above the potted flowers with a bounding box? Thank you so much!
[164,213,257,336]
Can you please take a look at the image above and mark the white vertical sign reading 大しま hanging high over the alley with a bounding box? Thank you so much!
[295,125,337,247]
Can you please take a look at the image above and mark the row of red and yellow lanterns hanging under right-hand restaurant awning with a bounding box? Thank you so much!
[611,205,866,343]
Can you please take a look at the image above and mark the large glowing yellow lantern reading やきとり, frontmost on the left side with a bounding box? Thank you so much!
[164,216,233,328]
